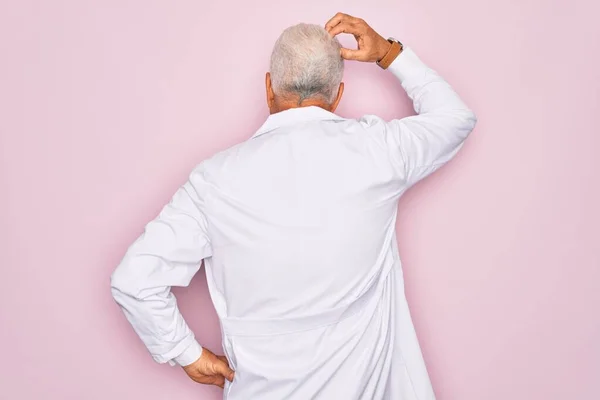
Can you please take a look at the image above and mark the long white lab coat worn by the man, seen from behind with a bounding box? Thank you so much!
[112,49,475,400]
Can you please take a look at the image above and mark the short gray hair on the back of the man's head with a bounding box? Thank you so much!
[270,24,344,104]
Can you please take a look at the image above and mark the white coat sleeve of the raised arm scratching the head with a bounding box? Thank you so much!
[383,48,477,185]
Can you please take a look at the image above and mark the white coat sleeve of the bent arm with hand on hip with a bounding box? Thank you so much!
[111,164,212,366]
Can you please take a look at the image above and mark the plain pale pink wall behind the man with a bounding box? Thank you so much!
[0,0,600,400]
